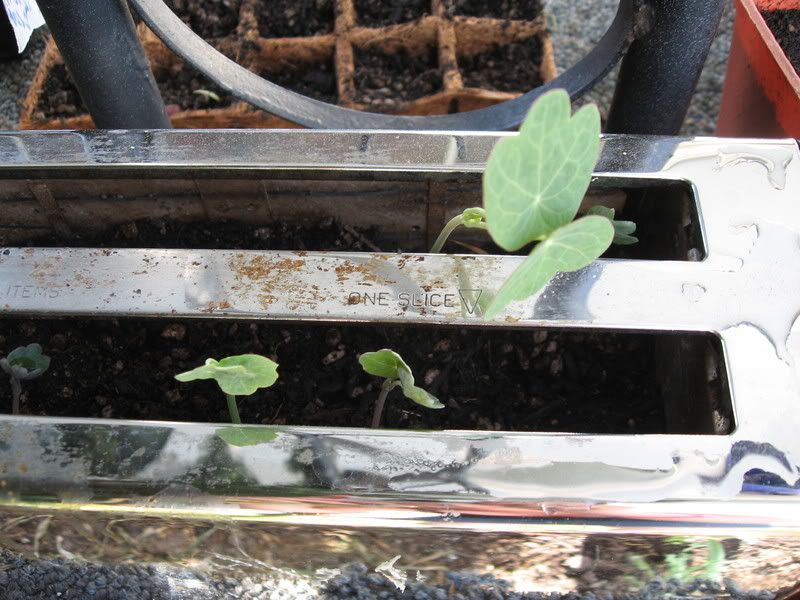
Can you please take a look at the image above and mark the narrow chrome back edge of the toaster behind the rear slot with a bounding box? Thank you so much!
[0,129,704,172]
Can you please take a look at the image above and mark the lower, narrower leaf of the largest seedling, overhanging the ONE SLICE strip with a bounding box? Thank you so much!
[484,215,614,320]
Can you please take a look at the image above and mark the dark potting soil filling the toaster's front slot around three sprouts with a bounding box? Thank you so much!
[0,319,664,433]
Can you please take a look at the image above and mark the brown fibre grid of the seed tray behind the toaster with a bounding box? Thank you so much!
[20,0,556,129]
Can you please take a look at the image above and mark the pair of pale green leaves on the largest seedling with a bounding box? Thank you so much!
[483,90,614,320]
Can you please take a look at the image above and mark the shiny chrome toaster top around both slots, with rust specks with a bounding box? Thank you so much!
[0,131,800,584]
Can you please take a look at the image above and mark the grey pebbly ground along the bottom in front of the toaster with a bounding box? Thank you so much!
[0,551,775,600]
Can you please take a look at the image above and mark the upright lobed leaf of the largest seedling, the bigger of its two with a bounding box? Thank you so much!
[483,90,600,251]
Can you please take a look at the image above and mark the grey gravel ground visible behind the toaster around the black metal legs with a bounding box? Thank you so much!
[0,0,734,135]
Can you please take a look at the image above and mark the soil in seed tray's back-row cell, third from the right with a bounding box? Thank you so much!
[258,0,335,38]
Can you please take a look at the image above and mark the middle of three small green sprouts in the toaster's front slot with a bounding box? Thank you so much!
[175,354,278,424]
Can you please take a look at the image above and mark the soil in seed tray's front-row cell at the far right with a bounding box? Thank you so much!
[458,36,544,92]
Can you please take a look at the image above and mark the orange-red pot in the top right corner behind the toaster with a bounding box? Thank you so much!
[717,0,800,138]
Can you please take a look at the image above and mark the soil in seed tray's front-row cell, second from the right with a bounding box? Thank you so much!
[354,48,442,111]
